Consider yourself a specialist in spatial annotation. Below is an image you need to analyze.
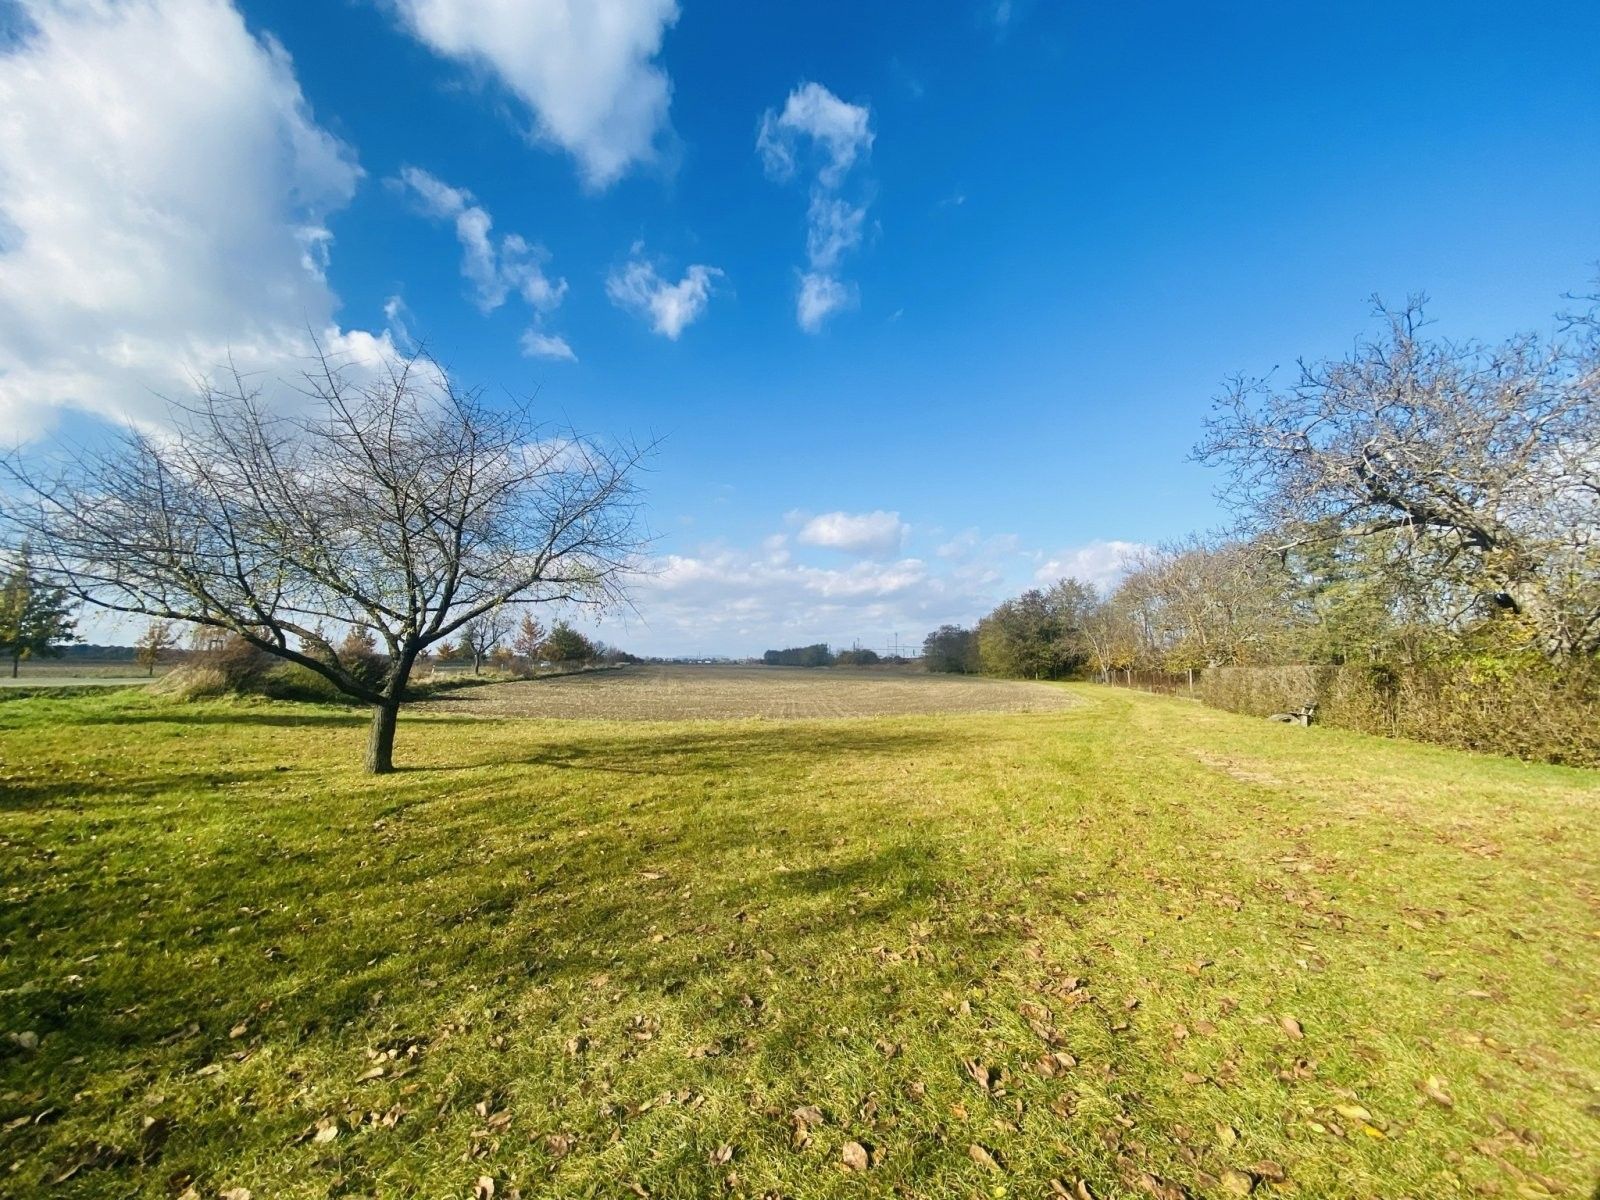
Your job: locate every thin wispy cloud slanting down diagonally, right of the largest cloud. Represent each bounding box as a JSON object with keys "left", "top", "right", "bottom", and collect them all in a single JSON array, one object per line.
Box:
[{"left": 398, "top": 166, "right": 578, "bottom": 362}]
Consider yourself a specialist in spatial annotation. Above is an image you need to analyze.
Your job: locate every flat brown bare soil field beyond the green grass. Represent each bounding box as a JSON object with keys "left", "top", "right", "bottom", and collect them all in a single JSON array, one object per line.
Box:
[{"left": 414, "top": 664, "right": 1078, "bottom": 722}]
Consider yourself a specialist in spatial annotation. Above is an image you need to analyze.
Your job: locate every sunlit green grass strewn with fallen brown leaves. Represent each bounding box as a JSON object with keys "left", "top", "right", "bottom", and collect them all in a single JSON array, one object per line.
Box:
[{"left": 0, "top": 688, "right": 1600, "bottom": 1200}]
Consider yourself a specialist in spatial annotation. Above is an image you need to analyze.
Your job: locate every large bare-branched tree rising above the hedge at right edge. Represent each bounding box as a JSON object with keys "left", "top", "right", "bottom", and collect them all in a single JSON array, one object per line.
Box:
[{"left": 1195, "top": 301, "right": 1600, "bottom": 656}]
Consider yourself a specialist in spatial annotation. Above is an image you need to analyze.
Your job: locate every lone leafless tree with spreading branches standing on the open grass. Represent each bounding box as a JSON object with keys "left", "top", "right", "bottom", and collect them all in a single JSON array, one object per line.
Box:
[{"left": 0, "top": 358, "right": 642, "bottom": 773}]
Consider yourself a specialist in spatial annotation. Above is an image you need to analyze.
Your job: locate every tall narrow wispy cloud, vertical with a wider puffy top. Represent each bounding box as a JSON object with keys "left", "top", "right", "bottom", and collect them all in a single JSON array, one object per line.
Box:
[{"left": 755, "top": 82, "right": 875, "bottom": 333}]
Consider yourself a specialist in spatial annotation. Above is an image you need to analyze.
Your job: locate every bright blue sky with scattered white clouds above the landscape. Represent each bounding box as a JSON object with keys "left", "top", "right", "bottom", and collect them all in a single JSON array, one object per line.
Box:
[{"left": 0, "top": 0, "right": 1600, "bottom": 653}]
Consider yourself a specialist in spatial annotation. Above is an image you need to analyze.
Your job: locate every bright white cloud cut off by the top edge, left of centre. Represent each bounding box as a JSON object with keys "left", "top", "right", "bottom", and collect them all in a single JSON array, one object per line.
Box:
[{"left": 390, "top": 0, "right": 678, "bottom": 187}]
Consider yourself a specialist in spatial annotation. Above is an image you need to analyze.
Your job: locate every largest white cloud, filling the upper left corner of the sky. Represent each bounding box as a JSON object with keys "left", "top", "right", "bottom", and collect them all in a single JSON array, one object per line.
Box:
[{"left": 0, "top": 0, "right": 406, "bottom": 435}]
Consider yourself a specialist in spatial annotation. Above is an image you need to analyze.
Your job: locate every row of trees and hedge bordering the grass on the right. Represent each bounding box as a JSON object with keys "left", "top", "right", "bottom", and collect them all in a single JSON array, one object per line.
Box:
[{"left": 923, "top": 298, "right": 1600, "bottom": 763}]
